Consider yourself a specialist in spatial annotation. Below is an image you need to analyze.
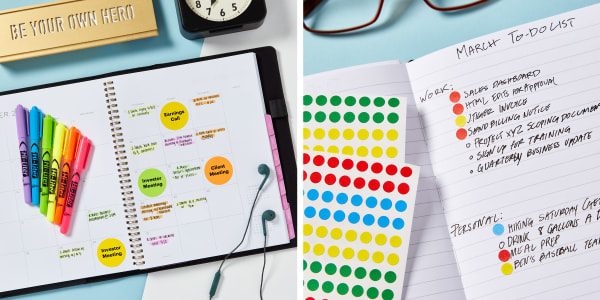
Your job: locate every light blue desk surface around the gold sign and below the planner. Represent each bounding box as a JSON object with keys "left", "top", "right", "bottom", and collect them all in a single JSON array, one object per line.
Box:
[{"left": 0, "top": 0, "right": 202, "bottom": 300}]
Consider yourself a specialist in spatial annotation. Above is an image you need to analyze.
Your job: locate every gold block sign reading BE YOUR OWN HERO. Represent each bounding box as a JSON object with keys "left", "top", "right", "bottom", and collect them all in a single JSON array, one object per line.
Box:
[{"left": 0, "top": 0, "right": 158, "bottom": 63}]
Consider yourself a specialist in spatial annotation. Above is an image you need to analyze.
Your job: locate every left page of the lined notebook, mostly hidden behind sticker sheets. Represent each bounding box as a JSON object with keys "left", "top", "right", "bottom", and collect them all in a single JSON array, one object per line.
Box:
[{"left": 304, "top": 62, "right": 464, "bottom": 299}]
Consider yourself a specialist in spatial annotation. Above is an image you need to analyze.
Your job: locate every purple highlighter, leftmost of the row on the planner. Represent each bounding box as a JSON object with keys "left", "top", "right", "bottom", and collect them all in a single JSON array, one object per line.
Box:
[{"left": 15, "top": 104, "right": 31, "bottom": 204}]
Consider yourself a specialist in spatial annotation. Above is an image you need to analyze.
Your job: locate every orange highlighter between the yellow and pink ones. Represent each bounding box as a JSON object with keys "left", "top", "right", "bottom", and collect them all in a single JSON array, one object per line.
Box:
[{"left": 54, "top": 127, "right": 80, "bottom": 225}]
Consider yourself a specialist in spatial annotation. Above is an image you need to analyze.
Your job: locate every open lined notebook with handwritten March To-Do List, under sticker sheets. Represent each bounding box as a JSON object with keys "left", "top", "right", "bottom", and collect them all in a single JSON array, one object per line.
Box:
[{"left": 304, "top": 5, "right": 600, "bottom": 299}]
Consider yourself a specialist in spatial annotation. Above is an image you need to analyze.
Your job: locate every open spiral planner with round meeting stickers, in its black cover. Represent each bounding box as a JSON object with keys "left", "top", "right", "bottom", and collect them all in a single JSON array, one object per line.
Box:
[{"left": 0, "top": 48, "right": 296, "bottom": 296}]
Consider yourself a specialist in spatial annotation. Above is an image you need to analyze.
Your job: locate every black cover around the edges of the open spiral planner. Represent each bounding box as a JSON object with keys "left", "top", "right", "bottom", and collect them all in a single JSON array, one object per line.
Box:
[{"left": 0, "top": 47, "right": 298, "bottom": 298}]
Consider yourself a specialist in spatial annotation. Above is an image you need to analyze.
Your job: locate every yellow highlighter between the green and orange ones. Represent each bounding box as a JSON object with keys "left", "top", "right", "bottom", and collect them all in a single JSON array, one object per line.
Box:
[{"left": 46, "top": 123, "right": 67, "bottom": 222}]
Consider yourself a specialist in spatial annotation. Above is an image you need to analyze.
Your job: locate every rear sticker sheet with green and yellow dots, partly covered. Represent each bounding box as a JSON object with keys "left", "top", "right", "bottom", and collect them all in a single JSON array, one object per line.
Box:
[{"left": 302, "top": 95, "right": 406, "bottom": 161}]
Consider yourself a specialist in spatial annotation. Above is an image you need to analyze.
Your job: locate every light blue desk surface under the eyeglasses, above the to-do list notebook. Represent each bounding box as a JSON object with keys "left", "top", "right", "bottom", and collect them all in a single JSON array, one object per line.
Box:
[{"left": 304, "top": 0, "right": 600, "bottom": 75}]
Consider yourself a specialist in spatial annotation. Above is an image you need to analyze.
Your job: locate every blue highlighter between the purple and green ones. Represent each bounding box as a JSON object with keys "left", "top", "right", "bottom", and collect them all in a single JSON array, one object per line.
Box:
[{"left": 29, "top": 106, "right": 44, "bottom": 206}]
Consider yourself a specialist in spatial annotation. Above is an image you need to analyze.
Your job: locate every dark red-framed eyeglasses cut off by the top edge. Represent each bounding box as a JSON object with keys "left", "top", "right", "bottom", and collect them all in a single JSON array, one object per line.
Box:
[{"left": 304, "top": 0, "right": 488, "bottom": 34}]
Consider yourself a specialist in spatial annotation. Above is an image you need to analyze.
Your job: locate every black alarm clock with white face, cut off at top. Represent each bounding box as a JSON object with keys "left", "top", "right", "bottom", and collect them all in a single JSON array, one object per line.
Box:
[{"left": 176, "top": 0, "right": 266, "bottom": 40}]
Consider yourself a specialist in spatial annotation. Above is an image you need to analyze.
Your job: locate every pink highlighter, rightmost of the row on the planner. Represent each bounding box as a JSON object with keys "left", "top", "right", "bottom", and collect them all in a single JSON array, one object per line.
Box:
[{"left": 60, "top": 136, "right": 92, "bottom": 234}]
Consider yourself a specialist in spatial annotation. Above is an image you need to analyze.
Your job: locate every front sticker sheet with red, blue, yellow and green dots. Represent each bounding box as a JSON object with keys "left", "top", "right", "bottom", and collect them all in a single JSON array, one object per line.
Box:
[{"left": 302, "top": 151, "right": 419, "bottom": 300}]
